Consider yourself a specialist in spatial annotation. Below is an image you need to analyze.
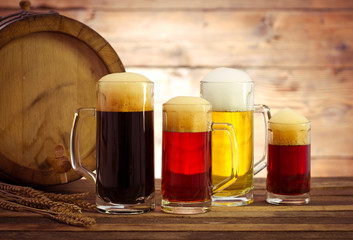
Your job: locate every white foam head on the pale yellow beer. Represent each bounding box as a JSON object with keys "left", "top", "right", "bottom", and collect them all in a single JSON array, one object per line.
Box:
[{"left": 201, "top": 67, "right": 254, "bottom": 112}]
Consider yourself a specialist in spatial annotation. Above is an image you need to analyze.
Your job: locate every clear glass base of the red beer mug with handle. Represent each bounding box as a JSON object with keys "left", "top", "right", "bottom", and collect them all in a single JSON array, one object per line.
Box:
[{"left": 161, "top": 199, "right": 211, "bottom": 214}]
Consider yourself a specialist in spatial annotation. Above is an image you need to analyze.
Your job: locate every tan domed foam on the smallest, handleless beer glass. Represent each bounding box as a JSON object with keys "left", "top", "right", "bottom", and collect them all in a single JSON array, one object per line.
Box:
[{"left": 270, "top": 108, "right": 310, "bottom": 146}]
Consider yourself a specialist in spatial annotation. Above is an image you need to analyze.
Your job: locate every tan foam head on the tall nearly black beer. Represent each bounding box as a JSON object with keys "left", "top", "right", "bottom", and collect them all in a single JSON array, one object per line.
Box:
[{"left": 97, "top": 72, "right": 153, "bottom": 112}]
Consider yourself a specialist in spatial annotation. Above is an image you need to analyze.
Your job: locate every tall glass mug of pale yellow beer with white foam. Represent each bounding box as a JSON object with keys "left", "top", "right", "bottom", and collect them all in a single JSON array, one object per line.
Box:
[{"left": 201, "top": 68, "right": 270, "bottom": 206}]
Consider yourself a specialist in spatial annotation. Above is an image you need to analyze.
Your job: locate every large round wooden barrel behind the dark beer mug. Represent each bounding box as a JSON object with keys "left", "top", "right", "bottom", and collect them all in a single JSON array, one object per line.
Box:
[{"left": 0, "top": 1, "right": 125, "bottom": 186}]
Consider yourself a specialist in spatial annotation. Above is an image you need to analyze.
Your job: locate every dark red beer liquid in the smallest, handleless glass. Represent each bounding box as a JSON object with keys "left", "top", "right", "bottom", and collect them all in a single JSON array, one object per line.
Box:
[{"left": 267, "top": 144, "right": 310, "bottom": 195}]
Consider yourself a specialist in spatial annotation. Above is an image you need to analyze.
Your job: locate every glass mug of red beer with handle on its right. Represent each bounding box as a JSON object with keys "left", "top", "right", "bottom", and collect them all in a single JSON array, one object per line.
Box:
[{"left": 161, "top": 97, "right": 237, "bottom": 214}]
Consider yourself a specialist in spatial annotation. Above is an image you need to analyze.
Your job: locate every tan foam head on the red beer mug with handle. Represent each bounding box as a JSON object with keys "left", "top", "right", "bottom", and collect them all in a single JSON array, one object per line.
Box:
[{"left": 163, "top": 96, "right": 212, "bottom": 132}]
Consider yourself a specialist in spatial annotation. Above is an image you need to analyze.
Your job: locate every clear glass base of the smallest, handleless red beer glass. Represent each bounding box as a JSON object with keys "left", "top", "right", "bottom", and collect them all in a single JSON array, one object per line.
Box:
[{"left": 266, "top": 192, "right": 310, "bottom": 205}]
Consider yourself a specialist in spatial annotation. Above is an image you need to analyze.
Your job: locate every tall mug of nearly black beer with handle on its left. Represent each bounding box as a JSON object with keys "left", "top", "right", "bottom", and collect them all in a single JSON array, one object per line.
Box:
[{"left": 70, "top": 73, "right": 155, "bottom": 214}]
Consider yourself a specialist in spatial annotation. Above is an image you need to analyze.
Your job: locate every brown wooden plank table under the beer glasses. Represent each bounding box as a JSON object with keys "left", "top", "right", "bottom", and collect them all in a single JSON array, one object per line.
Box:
[{"left": 0, "top": 177, "right": 353, "bottom": 240}]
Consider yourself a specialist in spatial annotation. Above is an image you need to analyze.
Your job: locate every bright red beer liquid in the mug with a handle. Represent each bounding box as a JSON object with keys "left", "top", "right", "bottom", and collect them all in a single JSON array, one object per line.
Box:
[{"left": 162, "top": 131, "right": 211, "bottom": 202}]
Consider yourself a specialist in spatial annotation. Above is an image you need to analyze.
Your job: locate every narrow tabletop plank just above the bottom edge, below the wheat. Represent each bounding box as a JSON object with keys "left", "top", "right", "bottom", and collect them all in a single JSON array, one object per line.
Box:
[{"left": 0, "top": 223, "right": 353, "bottom": 232}]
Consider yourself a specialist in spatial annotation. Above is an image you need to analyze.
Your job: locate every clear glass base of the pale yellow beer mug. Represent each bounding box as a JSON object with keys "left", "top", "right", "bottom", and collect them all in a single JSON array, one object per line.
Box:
[{"left": 212, "top": 191, "right": 254, "bottom": 207}]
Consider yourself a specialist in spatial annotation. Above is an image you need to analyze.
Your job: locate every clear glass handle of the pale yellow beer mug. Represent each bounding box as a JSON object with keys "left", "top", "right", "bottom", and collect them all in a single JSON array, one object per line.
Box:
[{"left": 254, "top": 104, "right": 271, "bottom": 175}]
